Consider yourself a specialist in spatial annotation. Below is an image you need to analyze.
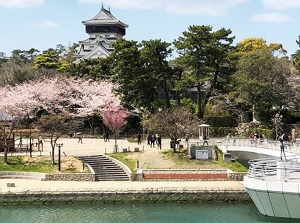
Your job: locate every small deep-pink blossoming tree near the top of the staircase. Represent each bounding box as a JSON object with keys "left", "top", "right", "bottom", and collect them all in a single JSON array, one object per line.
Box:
[{"left": 103, "top": 104, "right": 128, "bottom": 152}]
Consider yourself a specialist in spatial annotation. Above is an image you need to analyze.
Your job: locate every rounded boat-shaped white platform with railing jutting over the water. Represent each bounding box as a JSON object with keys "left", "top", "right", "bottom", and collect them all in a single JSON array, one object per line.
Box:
[{"left": 244, "top": 155, "right": 300, "bottom": 219}]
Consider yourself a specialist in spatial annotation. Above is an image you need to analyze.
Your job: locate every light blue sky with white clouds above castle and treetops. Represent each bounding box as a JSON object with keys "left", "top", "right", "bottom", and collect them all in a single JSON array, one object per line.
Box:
[{"left": 0, "top": 0, "right": 300, "bottom": 56}]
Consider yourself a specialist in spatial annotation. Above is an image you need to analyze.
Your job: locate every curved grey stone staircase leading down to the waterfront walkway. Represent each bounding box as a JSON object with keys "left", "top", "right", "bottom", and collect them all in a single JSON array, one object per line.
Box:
[{"left": 78, "top": 155, "right": 130, "bottom": 181}]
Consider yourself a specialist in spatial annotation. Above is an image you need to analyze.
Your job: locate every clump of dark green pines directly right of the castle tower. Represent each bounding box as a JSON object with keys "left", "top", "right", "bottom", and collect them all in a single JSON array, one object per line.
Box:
[{"left": 110, "top": 39, "right": 175, "bottom": 111}]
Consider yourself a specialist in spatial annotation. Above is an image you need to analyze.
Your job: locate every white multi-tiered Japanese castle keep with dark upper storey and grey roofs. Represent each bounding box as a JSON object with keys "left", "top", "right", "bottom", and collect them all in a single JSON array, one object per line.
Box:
[{"left": 74, "top": 5, "right": 128, "bottom": 63}]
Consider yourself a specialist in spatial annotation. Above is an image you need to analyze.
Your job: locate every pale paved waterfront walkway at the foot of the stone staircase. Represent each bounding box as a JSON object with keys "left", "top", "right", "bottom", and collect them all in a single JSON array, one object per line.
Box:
[{"left": 0, "top": 179, "right": 245, "bottom": 193}]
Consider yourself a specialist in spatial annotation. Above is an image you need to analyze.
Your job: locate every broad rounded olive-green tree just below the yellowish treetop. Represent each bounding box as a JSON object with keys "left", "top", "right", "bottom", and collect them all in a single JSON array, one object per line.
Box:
[{"left": 233, "top": 49, "right": 299, "bottom": 124}]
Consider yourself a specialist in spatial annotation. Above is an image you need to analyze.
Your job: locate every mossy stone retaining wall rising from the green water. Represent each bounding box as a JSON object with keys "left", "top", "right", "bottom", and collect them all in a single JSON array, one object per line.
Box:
[{"left": 0, "top": 188, "right": 252, "bottom": 206}]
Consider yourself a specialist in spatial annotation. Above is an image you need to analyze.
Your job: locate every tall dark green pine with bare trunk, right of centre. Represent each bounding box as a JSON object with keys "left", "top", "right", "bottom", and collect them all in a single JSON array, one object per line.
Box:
[{"left": 174, "top": 26, "right": 235, "bottom": 118}]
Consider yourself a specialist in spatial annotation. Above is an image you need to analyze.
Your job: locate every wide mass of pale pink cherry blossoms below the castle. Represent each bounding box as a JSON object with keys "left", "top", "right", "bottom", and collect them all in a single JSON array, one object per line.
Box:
[{"left": 0, "top": 77, "right": 120, "bottom": 163}]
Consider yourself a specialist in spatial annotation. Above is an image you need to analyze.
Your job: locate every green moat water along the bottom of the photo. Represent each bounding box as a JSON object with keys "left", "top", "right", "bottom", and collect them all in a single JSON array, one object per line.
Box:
[{"left": 0, "top": 204, "right": 299, "bottom": 223}]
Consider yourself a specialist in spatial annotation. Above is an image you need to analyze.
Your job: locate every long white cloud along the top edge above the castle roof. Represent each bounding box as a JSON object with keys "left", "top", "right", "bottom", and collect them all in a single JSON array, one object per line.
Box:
[{"left": 78, "top": 0, "right": 250, "bottom": 16}]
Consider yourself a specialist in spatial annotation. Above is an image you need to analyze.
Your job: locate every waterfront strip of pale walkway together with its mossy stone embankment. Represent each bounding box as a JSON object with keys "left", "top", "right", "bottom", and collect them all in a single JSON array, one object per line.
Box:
[{"left": 0, "top": 179, "right": 252, "bottom": 206}]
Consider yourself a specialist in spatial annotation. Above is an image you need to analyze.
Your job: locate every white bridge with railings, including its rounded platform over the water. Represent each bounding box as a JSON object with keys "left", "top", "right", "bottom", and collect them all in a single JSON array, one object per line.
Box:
[{"left": 217, "top": 139, "right": 300, "bottom": 218}]
